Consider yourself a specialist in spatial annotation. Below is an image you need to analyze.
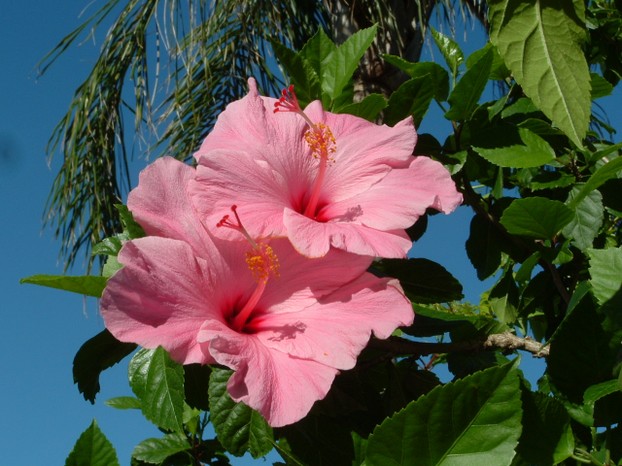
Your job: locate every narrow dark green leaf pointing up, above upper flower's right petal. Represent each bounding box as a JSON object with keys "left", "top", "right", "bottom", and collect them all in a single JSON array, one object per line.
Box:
[{"left": 445, "top": 49, "right": 493, "bottom": 121}]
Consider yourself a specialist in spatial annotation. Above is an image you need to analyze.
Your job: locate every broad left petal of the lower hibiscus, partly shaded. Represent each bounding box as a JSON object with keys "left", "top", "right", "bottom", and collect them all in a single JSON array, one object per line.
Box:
[{"left": 100, "top": 237, "right": 222, "bottom": 364}]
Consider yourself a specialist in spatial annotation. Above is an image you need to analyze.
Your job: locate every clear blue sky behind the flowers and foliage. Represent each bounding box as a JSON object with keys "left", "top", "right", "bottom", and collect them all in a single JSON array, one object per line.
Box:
[{"left": 0, "top": 0, "right": 620, "bottom": 466}]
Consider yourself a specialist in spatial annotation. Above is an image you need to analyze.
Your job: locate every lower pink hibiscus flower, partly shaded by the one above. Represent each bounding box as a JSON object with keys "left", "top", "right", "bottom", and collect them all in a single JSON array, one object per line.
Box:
[{"left": 101, "top": 158, "right": 413, "bottom": 426}]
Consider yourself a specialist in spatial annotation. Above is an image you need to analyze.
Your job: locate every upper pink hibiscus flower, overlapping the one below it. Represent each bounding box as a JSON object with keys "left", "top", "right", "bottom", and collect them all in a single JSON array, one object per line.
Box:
[{"left": 191, "top": 79, "right": 462, "bottom": 257}]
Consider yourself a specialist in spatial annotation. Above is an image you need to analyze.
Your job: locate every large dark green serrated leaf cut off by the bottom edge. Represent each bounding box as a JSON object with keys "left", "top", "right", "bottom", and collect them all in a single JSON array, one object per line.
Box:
[{"left": 365, "top": 363, "right": 522, "bottom": 466}]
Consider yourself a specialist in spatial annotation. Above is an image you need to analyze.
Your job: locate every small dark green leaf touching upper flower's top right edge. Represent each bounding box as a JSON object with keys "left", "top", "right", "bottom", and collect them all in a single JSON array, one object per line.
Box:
[{"left": 384, "top": 76, "right": 434, "bottom": 126}]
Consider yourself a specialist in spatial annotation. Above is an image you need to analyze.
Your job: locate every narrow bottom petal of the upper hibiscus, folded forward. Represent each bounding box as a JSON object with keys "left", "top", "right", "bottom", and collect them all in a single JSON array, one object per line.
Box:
[{"left": 283, "top": 209, "right": 412, "bottom": 258}]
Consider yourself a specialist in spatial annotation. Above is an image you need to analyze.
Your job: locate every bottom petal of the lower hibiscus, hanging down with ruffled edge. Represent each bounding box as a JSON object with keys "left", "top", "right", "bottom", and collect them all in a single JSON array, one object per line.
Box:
[{"left": 199, "top": 321, "right": 338, "bottom": 427}]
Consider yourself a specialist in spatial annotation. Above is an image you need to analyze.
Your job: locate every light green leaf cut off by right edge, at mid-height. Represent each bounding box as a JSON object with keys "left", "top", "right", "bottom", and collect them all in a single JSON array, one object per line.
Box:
[{"left": 587, "top": 247, "right": 622, "bottom": 306}]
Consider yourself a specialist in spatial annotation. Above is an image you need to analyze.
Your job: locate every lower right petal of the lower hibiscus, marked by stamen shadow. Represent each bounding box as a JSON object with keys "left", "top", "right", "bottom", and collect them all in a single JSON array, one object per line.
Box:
[{"left": 253, "top": 273, "right": 414, "bottom": 369}]
